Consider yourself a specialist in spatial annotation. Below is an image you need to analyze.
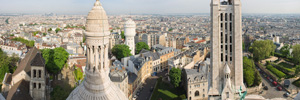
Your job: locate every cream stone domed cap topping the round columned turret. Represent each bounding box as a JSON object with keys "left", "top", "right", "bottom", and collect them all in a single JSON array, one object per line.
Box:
[{"left": 85, "top": 0, "right": 110, "bottom": 37}]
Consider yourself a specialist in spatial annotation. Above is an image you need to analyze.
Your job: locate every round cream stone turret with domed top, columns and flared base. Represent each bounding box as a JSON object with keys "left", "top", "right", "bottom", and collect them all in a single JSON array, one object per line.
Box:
[{"left": 67, "top": 0, "right": 128, "bottom": 100}]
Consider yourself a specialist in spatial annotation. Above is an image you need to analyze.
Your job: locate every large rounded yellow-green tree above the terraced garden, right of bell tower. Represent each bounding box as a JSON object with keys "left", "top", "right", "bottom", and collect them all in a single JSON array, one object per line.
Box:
[{"left": 251, "top": 40, "right": 276, "bottom": 61}]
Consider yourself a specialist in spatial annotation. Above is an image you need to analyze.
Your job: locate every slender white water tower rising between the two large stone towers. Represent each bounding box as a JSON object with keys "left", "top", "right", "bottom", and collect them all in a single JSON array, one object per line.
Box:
[{"left": 124, "top": 19, "right": 136, "bottom": 55}]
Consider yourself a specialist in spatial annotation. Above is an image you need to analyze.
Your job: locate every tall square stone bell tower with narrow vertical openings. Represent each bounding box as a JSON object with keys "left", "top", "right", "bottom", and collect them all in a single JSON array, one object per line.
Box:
[{"left": 208, "top": 0, "right": 246, "bottom": 100}]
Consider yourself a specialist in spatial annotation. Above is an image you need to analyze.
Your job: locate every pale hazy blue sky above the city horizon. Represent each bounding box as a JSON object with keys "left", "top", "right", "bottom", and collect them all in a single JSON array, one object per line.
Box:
[{"left": 0, "top": 0, "right": 300, "bottom": 14}]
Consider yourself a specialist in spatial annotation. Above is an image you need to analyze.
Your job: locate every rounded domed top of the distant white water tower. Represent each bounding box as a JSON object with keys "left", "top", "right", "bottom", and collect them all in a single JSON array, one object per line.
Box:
[{"left": 124, "top": 19, "right": 136, "bottom": 37}]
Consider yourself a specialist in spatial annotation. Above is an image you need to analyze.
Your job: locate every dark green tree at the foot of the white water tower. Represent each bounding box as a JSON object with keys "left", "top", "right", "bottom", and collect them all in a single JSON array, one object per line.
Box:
[{"left": 111, "top": 45, "right": 132, "bottom": 60}]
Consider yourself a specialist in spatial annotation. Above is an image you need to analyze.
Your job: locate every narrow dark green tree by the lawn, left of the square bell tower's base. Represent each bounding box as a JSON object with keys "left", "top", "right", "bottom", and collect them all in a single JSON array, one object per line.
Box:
[{"left": 169, "top": 68, "right": 181, "bottom": 88}]
